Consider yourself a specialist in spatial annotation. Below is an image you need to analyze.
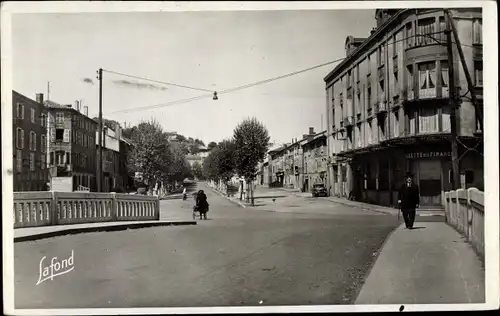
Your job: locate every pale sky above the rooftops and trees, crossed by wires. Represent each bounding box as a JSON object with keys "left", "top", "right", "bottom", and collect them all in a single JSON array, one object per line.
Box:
[{"left": 12, "top": 9, "right": 375, "bottom": 144}]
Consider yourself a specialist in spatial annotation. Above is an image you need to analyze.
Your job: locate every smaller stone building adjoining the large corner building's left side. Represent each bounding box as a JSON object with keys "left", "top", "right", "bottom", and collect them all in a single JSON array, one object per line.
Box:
[{"left": 302, "top": 131, "right": 328, "bottom": 192}]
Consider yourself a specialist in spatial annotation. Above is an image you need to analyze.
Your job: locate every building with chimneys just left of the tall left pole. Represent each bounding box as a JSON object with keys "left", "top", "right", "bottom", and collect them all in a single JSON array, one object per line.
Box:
[{"left": 45, "top": 100, "right": 97, "bottom": 191}]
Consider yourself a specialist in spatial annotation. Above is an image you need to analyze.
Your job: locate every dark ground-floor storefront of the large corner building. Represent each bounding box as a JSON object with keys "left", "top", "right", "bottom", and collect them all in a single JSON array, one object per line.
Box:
[{"left": 344, "top": 140, "right": 484, "bottom": 208}]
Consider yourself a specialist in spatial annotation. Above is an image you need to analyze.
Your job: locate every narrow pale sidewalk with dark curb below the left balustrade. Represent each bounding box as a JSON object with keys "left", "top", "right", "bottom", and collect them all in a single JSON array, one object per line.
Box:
[{"left": 14, "top": 220, "right": 196, "bottom": 242}]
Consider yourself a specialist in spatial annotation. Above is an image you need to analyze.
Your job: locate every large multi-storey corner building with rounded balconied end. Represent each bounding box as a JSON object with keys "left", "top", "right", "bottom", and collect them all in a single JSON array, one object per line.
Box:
[{"left": 324, "top": 8, "right": 483, "bottom": 206}]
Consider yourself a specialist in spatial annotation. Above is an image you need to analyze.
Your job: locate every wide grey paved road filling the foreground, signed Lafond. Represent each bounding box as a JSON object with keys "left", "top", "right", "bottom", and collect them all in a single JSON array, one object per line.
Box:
[{"left": 14, "top": 183, "right": 398, "bottom": 308}]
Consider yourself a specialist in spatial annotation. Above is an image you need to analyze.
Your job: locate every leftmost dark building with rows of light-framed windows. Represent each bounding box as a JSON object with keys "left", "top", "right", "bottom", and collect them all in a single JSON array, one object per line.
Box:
[{"left": 12, "top": 91, "right": 48, "bottom": 191}]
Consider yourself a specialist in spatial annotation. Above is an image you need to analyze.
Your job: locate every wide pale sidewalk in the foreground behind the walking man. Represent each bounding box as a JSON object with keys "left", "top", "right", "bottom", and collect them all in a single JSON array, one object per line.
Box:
[{"left": 356, "top": 222, "right": 485, "bottom": 305}]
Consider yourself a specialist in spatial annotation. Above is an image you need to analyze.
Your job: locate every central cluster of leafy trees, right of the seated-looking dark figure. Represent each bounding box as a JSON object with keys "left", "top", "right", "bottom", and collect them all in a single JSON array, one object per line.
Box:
[{"left": 202, "top": 118, "right": 270, "bottom": 204}]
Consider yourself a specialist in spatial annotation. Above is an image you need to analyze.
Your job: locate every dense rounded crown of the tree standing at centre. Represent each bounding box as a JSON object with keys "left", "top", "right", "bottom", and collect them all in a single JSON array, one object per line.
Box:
[{"left": 233, "top": 118, "right": 270, "bottom": 180}]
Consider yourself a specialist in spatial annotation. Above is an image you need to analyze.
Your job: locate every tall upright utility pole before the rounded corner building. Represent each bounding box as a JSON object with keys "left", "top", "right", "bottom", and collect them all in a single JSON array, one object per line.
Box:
[{"left": 445, "top": 10, "right": 460, "bottom": 190}]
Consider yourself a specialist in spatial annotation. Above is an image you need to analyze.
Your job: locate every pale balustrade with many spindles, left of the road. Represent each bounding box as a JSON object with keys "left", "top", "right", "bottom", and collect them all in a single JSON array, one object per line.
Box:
[{"left": 14, "top": 192, "right": 160, "bottom": 228}]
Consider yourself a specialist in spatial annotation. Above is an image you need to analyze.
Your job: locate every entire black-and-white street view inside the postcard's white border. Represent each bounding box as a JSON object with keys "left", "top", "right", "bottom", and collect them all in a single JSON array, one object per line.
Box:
[{"left": 2, "top": 2, "right": 488, "bottom": 313}]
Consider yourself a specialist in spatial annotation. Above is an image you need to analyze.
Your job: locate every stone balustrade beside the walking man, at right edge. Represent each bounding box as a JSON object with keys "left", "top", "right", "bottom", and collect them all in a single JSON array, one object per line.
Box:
[{"left": 445, "top": 188, "right": 484, "bottom": 258}]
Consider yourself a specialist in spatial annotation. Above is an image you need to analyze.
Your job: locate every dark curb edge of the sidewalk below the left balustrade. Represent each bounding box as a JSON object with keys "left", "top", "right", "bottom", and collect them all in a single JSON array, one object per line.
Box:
[{"left": 14, "top": 221, "right": 196, "bottom": 242}]
